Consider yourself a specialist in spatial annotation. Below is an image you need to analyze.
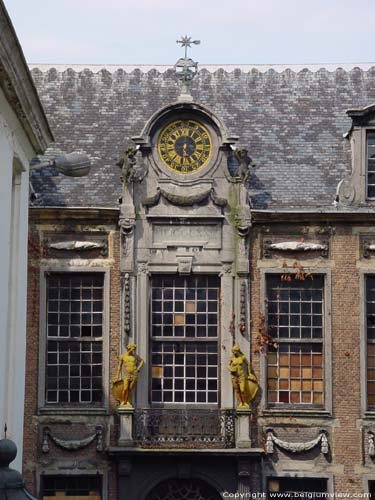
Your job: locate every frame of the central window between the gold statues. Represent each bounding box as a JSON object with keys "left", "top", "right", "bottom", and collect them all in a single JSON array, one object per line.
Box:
[{"left": 147, "top": 271, "right": 222, "bottom": 410}]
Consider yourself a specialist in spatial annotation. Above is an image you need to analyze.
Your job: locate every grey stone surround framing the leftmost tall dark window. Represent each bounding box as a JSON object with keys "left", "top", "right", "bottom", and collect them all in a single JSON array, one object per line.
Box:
[{"left": 38, "top": 265, "right": 110, "bottom": 414}]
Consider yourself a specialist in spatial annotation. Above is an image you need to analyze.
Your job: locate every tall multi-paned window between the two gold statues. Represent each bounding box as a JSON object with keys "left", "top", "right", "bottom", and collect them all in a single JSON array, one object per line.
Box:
[{"left": 151, "top": 276, "right": 220, "bottom": 404}]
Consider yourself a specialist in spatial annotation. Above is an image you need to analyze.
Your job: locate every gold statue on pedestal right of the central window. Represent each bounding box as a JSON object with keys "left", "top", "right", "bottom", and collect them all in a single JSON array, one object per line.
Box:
[{"left": 227, "top": 345, "right": 259, "bottom": 410}]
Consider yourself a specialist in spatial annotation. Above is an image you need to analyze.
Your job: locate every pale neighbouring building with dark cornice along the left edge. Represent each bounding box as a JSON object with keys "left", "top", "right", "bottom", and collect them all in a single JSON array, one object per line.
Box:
[{"left": 0, "top": 2, "right": 53, "bottom": 469}]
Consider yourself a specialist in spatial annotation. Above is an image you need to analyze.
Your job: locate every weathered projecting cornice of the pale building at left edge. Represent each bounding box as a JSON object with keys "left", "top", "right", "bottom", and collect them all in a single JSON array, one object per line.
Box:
[{"left": 0, "top": 0, "right": 54, "bottom": 153}]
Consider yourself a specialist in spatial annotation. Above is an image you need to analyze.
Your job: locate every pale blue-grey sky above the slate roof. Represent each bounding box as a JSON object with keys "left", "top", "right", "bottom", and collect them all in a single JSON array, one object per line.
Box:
[{"left": 5, "top": 0, "right": 375, "bottom": 65}]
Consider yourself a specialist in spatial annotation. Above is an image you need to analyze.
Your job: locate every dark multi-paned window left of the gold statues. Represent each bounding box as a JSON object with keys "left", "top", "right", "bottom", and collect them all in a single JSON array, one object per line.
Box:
[{"left": 46, "top": 273, "right": 104, "bottom": 404}]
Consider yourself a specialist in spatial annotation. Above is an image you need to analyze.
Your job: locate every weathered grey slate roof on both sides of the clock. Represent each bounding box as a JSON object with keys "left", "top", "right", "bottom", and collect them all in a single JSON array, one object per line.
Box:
[{"left": 31, "top": 63, "right": 375, "bottom": 209}]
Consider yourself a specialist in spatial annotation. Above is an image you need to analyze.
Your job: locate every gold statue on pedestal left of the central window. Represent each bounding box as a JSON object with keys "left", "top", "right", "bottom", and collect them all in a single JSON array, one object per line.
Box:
[{"left": 112, "top": 344, "right": 144, "bottom": 408}]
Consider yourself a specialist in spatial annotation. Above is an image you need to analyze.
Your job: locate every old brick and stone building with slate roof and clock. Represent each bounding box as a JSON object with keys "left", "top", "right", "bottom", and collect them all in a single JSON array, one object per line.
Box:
[{"left": 24, "top": 56, "right": 375, "bottom": 500}]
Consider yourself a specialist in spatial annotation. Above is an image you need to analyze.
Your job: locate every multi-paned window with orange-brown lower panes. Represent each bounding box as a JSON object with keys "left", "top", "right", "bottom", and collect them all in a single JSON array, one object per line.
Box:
[{"left": 267, "top": 275, "right": 324, "bottom": 406}]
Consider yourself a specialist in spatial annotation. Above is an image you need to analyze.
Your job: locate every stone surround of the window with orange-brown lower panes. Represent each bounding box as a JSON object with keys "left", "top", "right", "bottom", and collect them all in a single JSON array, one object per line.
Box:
[{"left": 260, "top": 266, "right": 332, "bottom": 417}]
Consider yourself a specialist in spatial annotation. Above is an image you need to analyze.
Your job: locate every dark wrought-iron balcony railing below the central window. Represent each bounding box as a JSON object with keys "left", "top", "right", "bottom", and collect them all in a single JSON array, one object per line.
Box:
[{"left": 133, "top": 408, "right": 235, "bottom": 448}]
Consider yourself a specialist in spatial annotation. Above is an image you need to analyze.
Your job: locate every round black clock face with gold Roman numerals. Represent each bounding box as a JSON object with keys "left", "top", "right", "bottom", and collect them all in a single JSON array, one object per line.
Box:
[{"left": 158, "top": 120, "right": 212, "bottom": 174}]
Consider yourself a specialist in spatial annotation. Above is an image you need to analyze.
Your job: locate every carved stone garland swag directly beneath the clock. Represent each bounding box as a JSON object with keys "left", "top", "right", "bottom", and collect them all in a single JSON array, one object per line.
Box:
[{"left": 142, "top": 186, "right": 228, "bottom": 207}]
